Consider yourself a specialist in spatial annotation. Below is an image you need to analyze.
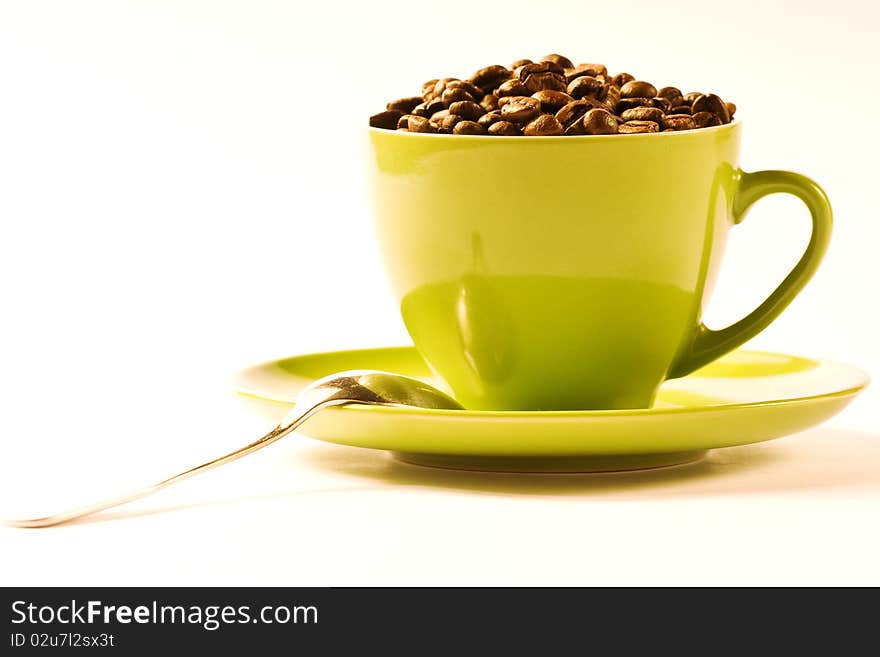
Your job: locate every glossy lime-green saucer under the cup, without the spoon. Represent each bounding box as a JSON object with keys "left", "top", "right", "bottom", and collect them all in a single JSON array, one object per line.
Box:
[{"left": 238, "top": 347, "right": 868, "bottom": 472}]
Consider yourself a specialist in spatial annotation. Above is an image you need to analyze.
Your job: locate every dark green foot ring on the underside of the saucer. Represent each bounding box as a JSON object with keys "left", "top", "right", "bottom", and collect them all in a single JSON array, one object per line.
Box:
[{"left": 392, "top": 450, "right": 707, "bottom": 474}]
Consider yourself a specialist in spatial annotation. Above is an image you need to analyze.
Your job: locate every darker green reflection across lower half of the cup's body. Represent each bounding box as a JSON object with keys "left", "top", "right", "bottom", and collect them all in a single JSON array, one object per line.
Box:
[{"left": 401, "top": 274, "right": 694, "bottom": 410}]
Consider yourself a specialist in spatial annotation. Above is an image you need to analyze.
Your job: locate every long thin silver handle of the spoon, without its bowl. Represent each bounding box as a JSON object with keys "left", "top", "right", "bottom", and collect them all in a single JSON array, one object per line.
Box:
[{"left": 9, "top": 397, "right": 351, "bottom": 528}]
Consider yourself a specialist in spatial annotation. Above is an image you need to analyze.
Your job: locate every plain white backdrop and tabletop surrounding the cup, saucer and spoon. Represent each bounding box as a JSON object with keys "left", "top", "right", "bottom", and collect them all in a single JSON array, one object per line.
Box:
[{"left": 0, "top": 0, "right": 880, "bottom": 584}]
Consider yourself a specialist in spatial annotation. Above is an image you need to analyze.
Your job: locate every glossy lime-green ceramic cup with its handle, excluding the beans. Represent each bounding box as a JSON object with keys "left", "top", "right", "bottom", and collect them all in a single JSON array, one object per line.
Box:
[{"left": 370, "top": 123, "right": 831, "bottom": 410}]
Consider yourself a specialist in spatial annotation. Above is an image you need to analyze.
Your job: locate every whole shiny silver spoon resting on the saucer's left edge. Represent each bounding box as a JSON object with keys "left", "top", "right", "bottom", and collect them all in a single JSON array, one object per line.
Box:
[{"left": 5, "top": 370, "right": 462, "bottom": 527}]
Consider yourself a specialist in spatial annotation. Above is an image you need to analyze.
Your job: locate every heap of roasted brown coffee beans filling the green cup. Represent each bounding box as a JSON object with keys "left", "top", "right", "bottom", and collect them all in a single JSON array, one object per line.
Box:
[{"left": 370, "top": 54, "right": 736, "bottom": 137}]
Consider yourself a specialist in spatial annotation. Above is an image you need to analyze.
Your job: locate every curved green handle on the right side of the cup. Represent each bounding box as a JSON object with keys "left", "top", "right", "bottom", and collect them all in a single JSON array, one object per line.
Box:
[{"left": 667, "top": 171, "right": 832, "bottom": 379}]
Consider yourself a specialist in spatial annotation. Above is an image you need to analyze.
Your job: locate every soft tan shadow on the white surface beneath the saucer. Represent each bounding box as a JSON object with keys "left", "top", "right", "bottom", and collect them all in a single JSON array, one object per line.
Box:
[{"left": 291, "top": 428, "right": 880, "bottom": 498}]
